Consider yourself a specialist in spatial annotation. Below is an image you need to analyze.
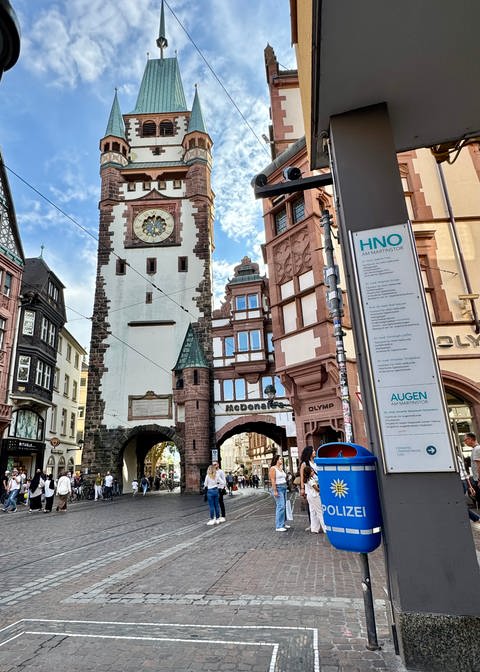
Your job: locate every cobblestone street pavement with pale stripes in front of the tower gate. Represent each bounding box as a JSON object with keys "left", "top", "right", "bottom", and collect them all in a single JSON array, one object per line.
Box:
[{"left": 0, "top": 490, "right": 480, "bottom": 672}]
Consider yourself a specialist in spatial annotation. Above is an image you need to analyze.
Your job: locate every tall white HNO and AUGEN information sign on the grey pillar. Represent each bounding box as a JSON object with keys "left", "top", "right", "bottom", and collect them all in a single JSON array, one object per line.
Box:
[{"left": 351, "top": 224, "right": 455, "bottom": 473}]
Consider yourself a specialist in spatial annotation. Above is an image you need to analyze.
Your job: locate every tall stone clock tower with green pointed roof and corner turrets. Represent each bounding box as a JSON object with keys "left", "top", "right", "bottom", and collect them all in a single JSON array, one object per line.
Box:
[{"left": 83, "top": 3, "right": 213, "bottom": 491}]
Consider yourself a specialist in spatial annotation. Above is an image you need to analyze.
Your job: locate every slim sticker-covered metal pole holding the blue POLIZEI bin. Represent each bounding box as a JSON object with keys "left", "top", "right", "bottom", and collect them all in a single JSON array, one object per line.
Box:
[{"left": 322, "top": 210, "right": 381, "bottom": 651}]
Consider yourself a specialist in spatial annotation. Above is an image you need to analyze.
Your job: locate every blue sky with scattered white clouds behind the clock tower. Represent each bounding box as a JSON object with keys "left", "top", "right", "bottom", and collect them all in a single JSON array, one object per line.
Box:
[{"left": 0, "top": 0, "right": 295, "bottom": 349}]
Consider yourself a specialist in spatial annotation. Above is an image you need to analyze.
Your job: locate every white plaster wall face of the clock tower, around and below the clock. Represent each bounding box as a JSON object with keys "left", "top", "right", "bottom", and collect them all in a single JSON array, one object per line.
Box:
[{"left": 102, "top": 197, "right": 203, "bottom": 428}]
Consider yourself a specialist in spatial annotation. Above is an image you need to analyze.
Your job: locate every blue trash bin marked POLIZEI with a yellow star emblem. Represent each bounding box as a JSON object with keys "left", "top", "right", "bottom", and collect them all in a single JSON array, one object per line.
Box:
[{"left": 315, "top": 443, "right": 382, "bottom": 553}]
